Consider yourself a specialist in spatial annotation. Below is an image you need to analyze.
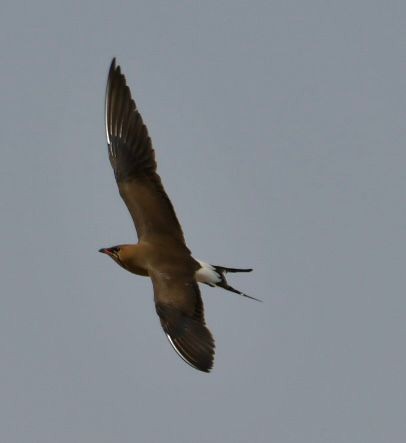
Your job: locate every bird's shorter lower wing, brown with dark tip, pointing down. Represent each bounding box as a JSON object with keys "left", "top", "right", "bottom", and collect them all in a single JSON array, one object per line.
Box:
[{"left": 150, "top": 272, "right": 215, "bottom": 372}]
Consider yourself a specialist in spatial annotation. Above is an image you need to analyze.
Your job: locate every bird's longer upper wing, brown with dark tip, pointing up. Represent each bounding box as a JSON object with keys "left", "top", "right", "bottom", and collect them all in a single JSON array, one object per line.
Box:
[{"left": 105, "top": 59, "right": 184, "bottom": 243}]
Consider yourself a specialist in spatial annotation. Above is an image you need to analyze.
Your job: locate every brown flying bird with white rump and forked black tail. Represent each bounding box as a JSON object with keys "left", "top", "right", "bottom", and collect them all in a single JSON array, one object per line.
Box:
[{"left": 99, "top": 58, "right": 261, "bottom": 372}]
